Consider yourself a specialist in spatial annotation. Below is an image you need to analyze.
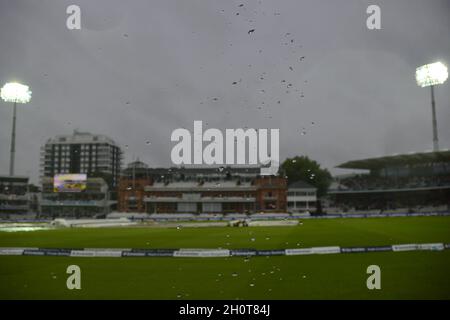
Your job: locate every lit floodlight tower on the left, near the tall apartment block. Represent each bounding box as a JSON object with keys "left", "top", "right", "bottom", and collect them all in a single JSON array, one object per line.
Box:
[{"left": 0, "top": 82, "right": 31, "bottom": 176}]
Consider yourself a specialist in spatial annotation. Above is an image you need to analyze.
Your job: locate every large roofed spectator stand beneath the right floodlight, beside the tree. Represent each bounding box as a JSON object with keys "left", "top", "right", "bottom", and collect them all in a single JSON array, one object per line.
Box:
[{"left": 327, "top": 150, "right": 450, "bottom": 213}]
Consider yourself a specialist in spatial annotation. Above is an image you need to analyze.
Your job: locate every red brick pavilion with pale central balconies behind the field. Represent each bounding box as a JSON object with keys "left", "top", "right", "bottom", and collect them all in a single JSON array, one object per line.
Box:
[{"left": 119, "top": 167, "right": 287, "bottom": 213}]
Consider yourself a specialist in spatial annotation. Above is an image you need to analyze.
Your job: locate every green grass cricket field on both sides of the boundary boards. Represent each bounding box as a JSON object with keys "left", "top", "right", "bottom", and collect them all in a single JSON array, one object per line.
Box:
[{"left": 0, "top": 217, "right": 450, "bottom": 299}]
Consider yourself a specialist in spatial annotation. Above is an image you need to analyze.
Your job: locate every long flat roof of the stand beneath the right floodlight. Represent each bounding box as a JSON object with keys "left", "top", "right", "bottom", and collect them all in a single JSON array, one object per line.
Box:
[{"left": 336, "top": 149, "right": 450, "bottom": 170}]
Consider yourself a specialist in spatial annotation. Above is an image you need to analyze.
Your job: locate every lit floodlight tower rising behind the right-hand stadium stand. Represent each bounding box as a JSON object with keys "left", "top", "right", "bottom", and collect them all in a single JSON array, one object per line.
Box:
[{"left": 416, "top": 62, "right": 448, "bottom": 151}]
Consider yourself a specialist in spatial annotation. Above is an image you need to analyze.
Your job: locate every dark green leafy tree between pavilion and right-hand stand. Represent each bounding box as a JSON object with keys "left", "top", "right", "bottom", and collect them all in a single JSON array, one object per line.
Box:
[{"left": 279, "top": 156, "right": 332, "bottom": 197}]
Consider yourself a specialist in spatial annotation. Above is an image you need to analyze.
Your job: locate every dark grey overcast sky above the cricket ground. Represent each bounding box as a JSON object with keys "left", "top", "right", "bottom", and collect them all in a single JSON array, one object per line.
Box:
[{"left": 0, "top": 0, "right": 450, "bottom": 182}]
